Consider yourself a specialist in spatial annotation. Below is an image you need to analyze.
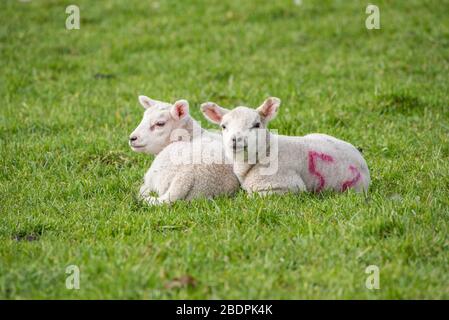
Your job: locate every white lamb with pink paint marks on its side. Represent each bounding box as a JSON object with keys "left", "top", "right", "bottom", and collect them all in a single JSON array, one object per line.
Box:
[{"left": 201, "top": 97, "right": 370, "bottom": 195}]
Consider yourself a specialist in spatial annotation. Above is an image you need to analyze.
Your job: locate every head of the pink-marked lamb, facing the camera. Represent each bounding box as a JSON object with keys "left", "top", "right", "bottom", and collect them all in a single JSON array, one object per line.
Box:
[{"left": 201, "top": 97, "right": 281, "bottom": 155}]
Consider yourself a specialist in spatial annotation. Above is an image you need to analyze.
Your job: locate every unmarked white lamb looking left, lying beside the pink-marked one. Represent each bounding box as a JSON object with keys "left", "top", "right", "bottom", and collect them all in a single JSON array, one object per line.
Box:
[{"left": 129, "top": 96, "right": 240, "bottom": 205}]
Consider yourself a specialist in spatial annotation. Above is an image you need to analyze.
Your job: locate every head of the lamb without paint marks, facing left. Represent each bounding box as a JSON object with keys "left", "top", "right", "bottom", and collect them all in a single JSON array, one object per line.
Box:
[{"left": 129, "top": 96, "right": 190, "bottom": 154}]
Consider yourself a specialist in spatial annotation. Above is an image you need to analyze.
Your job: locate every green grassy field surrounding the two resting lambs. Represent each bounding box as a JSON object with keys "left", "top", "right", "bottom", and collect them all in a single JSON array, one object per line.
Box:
[{"left": 0, "top": 0, "right": 449, "bottom": 299}]
